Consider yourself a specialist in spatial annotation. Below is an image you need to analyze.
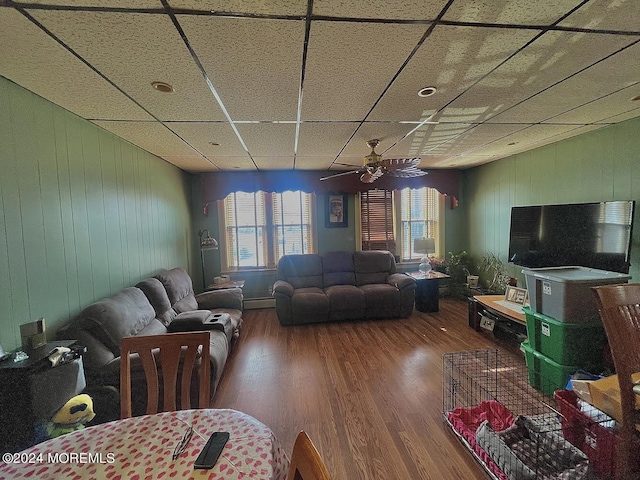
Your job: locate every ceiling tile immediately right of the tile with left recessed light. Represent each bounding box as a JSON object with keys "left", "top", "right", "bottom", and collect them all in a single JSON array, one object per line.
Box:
[{"left": 178, "top": 15, "right": 304, "bottom": 121}]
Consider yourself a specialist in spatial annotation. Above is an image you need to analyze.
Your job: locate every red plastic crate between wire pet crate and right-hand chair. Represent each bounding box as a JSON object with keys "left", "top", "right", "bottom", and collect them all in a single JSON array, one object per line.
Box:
[{"left": 554, "top": 390, "right": 640, "bottom": 478}]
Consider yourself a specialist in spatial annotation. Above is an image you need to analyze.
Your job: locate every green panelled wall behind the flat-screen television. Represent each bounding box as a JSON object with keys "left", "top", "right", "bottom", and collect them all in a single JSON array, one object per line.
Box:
[{"left": 460, "top": 118, "right": 640, "bottom": 285}]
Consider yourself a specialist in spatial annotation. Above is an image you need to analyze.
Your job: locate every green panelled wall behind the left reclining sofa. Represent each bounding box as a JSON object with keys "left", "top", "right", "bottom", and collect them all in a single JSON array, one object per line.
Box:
[{"left": 0, "top": 77, "right": 195, "bottom": 350}]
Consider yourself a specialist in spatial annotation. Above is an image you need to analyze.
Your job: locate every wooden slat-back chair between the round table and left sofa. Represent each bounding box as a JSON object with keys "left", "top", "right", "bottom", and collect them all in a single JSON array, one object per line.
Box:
[{"left": 120, "top": 331, "right": 211, "bottom": 418}]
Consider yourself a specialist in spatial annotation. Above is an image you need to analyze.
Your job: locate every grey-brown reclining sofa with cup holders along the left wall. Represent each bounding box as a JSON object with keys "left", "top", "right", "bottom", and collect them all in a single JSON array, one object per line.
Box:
[{"left": 57, "top": 268, "right": 243, "bottom": 413}]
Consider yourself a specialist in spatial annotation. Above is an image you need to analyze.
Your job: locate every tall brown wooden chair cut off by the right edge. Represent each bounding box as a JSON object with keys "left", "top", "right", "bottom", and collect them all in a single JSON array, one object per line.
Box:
[{"left": 592, "top": 283, "right": 640, "bottom": 480}]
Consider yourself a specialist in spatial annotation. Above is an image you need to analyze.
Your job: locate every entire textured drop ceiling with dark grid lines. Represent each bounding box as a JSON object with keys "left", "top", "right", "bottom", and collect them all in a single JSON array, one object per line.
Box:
[{"left": 0, "top": 0, "right": 640, "bottom": 173}]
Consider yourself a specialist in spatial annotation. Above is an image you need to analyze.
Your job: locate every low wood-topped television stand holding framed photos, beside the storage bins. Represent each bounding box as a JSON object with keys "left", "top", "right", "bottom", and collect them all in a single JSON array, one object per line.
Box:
[{"left": 469, "top": 295, "right": 527, "bottom": 346}]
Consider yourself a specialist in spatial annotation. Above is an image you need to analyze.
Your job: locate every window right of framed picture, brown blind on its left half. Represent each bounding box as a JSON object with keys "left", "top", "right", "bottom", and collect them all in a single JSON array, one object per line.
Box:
[{"left": 359, "top": 187, "right": 443, "bottom": 261}]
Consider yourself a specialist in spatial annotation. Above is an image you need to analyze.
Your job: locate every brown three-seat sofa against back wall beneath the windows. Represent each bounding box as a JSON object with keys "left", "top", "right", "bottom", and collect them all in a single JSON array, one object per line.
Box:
[{"left": 273, "top": 251, "right": 416, "bottom": 325}]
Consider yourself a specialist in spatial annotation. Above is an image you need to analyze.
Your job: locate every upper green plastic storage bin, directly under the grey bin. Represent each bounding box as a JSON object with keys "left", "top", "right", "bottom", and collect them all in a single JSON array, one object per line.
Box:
[{"left": 522, "top": 307, "right": 607, "bottom": 373}]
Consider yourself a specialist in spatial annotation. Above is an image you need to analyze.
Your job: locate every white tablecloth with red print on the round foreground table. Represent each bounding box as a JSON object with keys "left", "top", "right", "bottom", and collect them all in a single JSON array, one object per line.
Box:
[{"left": 0, "top": 409, "right": 289, "bottom": 480}]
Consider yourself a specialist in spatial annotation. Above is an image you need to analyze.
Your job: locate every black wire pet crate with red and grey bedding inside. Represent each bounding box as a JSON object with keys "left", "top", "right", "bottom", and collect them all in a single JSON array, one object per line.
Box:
[{"left": 442, "top": 350, "right": 610, "bottom": 480}]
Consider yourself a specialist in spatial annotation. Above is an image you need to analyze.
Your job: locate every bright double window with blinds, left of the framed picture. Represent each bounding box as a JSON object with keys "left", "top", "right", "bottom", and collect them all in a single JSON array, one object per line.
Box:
[{"left": 221, "top": 191, "right": 314, "bottom": 270}]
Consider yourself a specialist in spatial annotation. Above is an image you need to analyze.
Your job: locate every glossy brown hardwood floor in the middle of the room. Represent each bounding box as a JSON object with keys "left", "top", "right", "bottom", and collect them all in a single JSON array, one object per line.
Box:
[{"left": 213, "top": 299, "right": 517, "bottom": 480}]
